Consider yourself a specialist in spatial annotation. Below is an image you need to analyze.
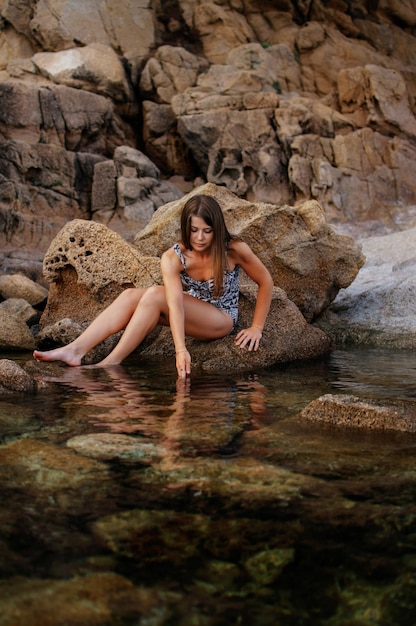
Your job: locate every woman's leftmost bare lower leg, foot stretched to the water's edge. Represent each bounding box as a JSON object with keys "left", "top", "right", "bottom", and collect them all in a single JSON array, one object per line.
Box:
[{"left": 33, "top": 288, "right": 145, "bottom": 366}]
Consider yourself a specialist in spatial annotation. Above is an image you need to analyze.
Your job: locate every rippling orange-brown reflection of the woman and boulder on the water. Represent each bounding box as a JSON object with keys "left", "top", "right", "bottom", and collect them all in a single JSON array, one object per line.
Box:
[{"left": 49, "top": 365, "right": 267, "bottom": 458}]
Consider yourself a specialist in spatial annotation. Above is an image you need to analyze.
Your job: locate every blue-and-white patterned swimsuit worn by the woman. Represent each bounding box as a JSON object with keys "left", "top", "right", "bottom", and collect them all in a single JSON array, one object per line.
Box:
[{"left": 173, "top": 243, "right": 240, "bottom": 328}]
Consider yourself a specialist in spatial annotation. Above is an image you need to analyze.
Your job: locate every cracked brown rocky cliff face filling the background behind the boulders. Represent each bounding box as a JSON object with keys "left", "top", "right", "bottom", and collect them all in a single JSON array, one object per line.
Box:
[{"left": 0, "top": 0, "right": 416, "bottom": 265}]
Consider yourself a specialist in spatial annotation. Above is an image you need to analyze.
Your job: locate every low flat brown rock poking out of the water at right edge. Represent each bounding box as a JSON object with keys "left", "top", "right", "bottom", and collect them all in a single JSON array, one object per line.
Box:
[{"left": 299, "top": 394, "right": 416, "bottom": 433}]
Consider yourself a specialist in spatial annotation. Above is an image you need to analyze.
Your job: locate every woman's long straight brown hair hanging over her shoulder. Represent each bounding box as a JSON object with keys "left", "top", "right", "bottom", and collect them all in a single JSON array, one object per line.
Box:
[{"left": 181, "top": 194, "right": 233, "bottom": 297}]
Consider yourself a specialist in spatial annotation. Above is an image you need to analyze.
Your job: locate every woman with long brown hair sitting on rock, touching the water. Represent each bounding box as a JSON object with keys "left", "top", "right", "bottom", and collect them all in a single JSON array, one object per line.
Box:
[{"left": 34, "top": 195, "right": 273, "bottom": 378}]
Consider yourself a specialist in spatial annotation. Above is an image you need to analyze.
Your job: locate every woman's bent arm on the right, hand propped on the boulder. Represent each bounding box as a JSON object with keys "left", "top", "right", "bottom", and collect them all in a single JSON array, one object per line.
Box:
[{"left": 231, "top": 240, "right": 273, "bottom": 352}]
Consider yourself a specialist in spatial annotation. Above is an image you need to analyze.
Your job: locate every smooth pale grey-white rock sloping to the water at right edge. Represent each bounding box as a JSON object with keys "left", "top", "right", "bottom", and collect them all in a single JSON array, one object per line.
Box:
[{"left": 317, "top": 228, "right": 416, "bottom": 349}]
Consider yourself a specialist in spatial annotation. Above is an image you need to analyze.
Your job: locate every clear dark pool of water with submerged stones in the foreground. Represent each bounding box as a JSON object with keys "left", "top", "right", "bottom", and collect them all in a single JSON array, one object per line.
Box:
[{"left": 0, "top": 349, "right": 416, "bottom": 626}]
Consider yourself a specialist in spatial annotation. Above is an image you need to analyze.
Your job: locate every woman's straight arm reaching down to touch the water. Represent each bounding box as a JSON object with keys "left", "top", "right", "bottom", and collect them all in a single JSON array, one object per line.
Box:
[{"left": 161, "top": 248, "right": 191, "bottom": 378}]
